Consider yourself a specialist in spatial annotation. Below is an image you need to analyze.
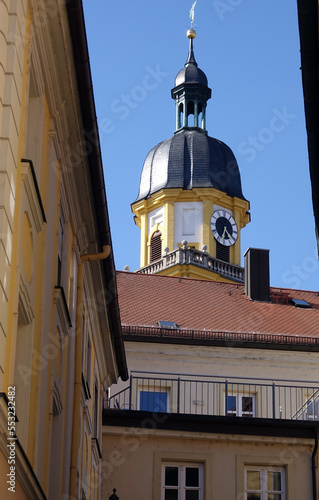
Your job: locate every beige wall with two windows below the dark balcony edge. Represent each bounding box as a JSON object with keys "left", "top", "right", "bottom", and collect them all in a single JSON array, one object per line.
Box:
[{"left": 102, "top": 426, "right": 314, "bottom": 500}]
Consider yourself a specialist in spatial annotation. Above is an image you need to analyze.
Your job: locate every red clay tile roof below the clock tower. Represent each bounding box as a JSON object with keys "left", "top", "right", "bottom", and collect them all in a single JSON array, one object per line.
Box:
[{"left": 117, "top": 271, "right": 319, "bottom": 337}]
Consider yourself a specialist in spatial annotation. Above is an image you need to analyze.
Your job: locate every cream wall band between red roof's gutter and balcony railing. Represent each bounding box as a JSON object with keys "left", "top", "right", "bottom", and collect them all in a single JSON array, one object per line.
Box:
[{"left": 120, "top": 342, "right": 319, "bottom": 391}]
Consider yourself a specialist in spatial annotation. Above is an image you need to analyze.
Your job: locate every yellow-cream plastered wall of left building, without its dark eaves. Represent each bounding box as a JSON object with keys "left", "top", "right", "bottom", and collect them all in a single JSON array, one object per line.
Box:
[{"left": 0, "top": 0, "right": 123, "bottom": 500}]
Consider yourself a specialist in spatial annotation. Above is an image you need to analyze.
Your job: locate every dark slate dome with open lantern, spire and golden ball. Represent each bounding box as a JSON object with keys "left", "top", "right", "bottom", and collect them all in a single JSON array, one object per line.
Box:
[{"left": 136, "top": 29, "right": 245, "bottom": 201}]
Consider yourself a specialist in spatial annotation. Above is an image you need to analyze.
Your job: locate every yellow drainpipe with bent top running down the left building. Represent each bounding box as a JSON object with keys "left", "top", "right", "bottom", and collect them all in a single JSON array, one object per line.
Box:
[{"left": 70, "top": 245, "right": 111, "bottom": 498}]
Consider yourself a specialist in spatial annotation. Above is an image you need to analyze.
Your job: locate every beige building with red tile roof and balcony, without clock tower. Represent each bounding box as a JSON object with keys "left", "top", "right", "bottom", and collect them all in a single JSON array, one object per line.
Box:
[{"left": 102, "top": 263, "right": 319, "bottom": 500}]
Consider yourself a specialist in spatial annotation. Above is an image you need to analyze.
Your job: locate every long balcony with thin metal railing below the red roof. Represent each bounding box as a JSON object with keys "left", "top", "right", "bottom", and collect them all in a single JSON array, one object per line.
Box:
[{"left": 104, "top": 371, "right": 319, "bottom": 421}]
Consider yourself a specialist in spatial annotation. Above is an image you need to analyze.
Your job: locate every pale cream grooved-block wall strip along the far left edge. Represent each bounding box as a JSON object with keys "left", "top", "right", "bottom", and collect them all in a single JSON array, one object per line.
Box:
[{"left": 0, "top": 0, "right": 26, "bottom": 387}]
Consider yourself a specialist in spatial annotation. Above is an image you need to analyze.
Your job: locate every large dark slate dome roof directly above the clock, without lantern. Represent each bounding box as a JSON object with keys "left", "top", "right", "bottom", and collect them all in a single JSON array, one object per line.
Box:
[{"left": 136, "top": 128, "right": 245, "bottom": 201}]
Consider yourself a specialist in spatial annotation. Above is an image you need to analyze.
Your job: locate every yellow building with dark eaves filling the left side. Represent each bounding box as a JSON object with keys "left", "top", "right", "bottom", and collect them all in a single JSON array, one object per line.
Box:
[{"left": 0, "top": 0, "right": 127, "bottom": 500}]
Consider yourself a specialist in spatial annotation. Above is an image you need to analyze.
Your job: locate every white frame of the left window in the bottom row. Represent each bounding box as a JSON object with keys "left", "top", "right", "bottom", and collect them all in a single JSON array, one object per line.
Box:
[{"left": 161, "top": 461, "right": 204, "bottom": 500}]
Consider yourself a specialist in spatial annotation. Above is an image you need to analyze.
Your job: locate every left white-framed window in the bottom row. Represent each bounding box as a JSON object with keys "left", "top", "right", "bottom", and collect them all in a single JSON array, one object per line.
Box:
[{"left": 161, "top": 463, "right": 203, "bottom": 500}]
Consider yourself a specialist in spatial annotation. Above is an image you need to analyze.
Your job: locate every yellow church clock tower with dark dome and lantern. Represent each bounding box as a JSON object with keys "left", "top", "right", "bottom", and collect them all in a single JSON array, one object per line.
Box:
[{"left": 132, "top": 29, "right": 250, "bottom": 282}]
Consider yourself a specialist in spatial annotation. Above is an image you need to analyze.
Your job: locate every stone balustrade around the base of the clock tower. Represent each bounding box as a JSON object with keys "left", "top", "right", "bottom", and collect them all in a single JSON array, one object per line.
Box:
[{"left": 136, "top": 242, "right": 245, "bottom": 283}]
